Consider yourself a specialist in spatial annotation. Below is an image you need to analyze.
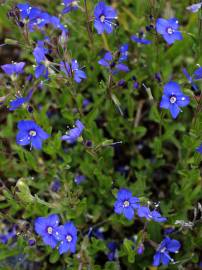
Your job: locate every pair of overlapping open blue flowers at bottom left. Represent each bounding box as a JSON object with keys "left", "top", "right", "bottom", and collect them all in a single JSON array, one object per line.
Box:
[{"left": 35, "top": 214, "right": 77, "bottom": 254}]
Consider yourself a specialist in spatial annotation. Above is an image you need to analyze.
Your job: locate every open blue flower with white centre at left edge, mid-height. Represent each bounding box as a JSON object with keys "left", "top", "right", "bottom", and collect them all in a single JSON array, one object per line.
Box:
[{"left": 16, "top": 120, "right": 50, "bottom": 149}]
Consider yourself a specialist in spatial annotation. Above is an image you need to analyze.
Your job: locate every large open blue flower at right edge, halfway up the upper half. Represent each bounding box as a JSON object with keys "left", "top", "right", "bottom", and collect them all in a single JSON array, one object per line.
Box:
[{"left": 160, "top": 81, "right": 190, "bottom": 119}]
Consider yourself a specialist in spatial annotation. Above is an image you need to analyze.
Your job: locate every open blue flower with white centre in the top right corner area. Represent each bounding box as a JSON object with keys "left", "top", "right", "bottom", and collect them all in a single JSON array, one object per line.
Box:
[{"left": 156, "top": 18, "right": 183, "bottom": 44}]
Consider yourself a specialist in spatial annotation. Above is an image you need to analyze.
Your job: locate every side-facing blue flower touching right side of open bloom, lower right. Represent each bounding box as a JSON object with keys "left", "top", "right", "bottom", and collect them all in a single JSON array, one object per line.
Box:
[{"left": 137, "top": 206, "right": 167, "bottom": 222}]
